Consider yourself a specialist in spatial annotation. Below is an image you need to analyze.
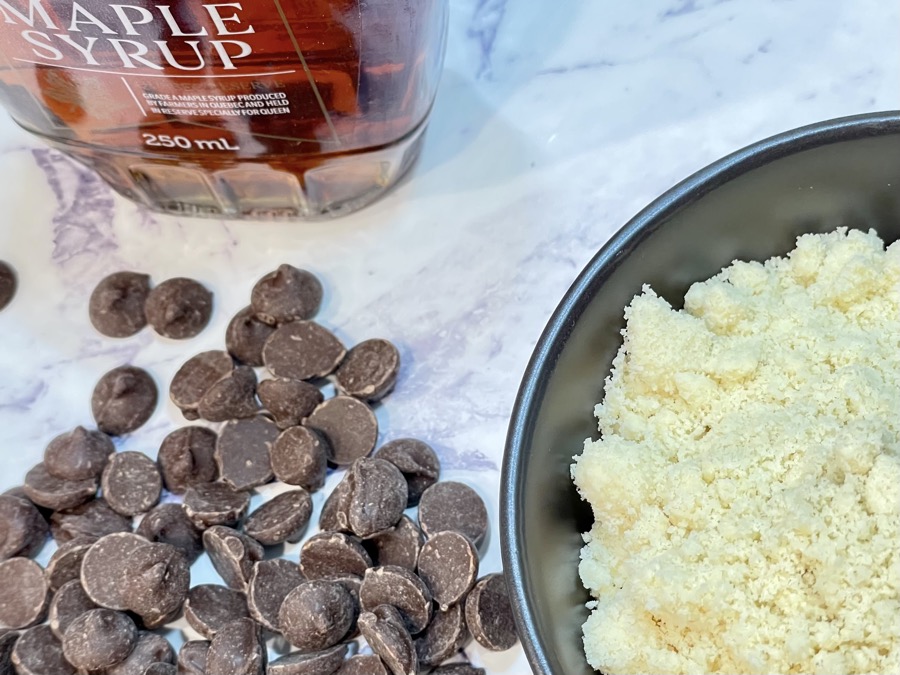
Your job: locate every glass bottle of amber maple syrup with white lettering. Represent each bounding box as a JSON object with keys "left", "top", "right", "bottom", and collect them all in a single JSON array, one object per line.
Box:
[{"left": 0, "top": 0, "right": 447, "bottom": 219}]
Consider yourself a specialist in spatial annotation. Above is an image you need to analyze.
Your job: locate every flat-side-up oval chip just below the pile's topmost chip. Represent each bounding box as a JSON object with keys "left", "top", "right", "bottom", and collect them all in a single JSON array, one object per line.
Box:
[{"left": 263, "top": 321, "right": 347, "bottom": 380}]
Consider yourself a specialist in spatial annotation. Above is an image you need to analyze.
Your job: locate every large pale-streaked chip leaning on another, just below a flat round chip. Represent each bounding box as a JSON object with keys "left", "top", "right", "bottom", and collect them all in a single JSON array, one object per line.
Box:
[{"left": 347, "top": 457, "right": 406, "bottom": 539}]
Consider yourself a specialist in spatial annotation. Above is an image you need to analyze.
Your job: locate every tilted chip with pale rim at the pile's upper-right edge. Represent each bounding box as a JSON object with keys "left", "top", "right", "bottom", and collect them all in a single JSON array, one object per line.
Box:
[{"left": 335, "top": 338, "right": 400, "bottom": 402}]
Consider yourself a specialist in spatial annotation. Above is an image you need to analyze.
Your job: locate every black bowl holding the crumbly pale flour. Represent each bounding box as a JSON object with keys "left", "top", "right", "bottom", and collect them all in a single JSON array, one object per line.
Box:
[{"left": 501, "top": 112, "right": 900, "bottom": 675}]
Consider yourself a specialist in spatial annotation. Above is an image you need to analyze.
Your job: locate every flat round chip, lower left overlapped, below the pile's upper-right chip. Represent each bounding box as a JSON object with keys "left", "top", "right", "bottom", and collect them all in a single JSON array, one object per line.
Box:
[{"left": 306, "top": 396, "right": 378, "bottom": 466}]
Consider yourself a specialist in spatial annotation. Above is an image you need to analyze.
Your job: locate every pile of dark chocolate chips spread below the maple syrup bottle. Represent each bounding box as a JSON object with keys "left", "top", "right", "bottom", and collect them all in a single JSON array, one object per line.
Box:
[{"left": 0, "top": 265, "right": 516, "bottom": 675}]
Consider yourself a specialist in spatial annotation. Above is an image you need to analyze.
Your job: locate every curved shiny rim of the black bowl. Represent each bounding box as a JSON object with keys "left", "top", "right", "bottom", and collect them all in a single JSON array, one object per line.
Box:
[{"left": 500, "top": 110, "right": 900, "bottom": 675}]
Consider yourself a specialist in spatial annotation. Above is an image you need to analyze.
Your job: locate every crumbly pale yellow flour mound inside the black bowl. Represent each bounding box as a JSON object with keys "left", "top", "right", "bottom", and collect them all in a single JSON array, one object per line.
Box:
[{"left": 572, "top": 229, "right": 900, "bottom": 675}]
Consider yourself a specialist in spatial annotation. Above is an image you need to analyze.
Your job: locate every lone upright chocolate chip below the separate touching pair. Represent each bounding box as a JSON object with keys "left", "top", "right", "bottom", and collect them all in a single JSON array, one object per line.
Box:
[{"left": 91, "top": 366, "right": 159, "bottom": 436}]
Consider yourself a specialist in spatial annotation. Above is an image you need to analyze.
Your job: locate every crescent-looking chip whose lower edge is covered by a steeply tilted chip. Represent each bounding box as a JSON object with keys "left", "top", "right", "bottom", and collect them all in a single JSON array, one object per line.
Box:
[{"left": 359, "top": 565, "right": 432, "bottom": 635}]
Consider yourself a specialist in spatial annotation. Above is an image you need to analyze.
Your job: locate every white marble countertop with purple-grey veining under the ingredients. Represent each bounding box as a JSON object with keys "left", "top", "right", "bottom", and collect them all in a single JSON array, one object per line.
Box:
[{"left": 0, "top": 0, "right": 900, "bottom": 675}]
